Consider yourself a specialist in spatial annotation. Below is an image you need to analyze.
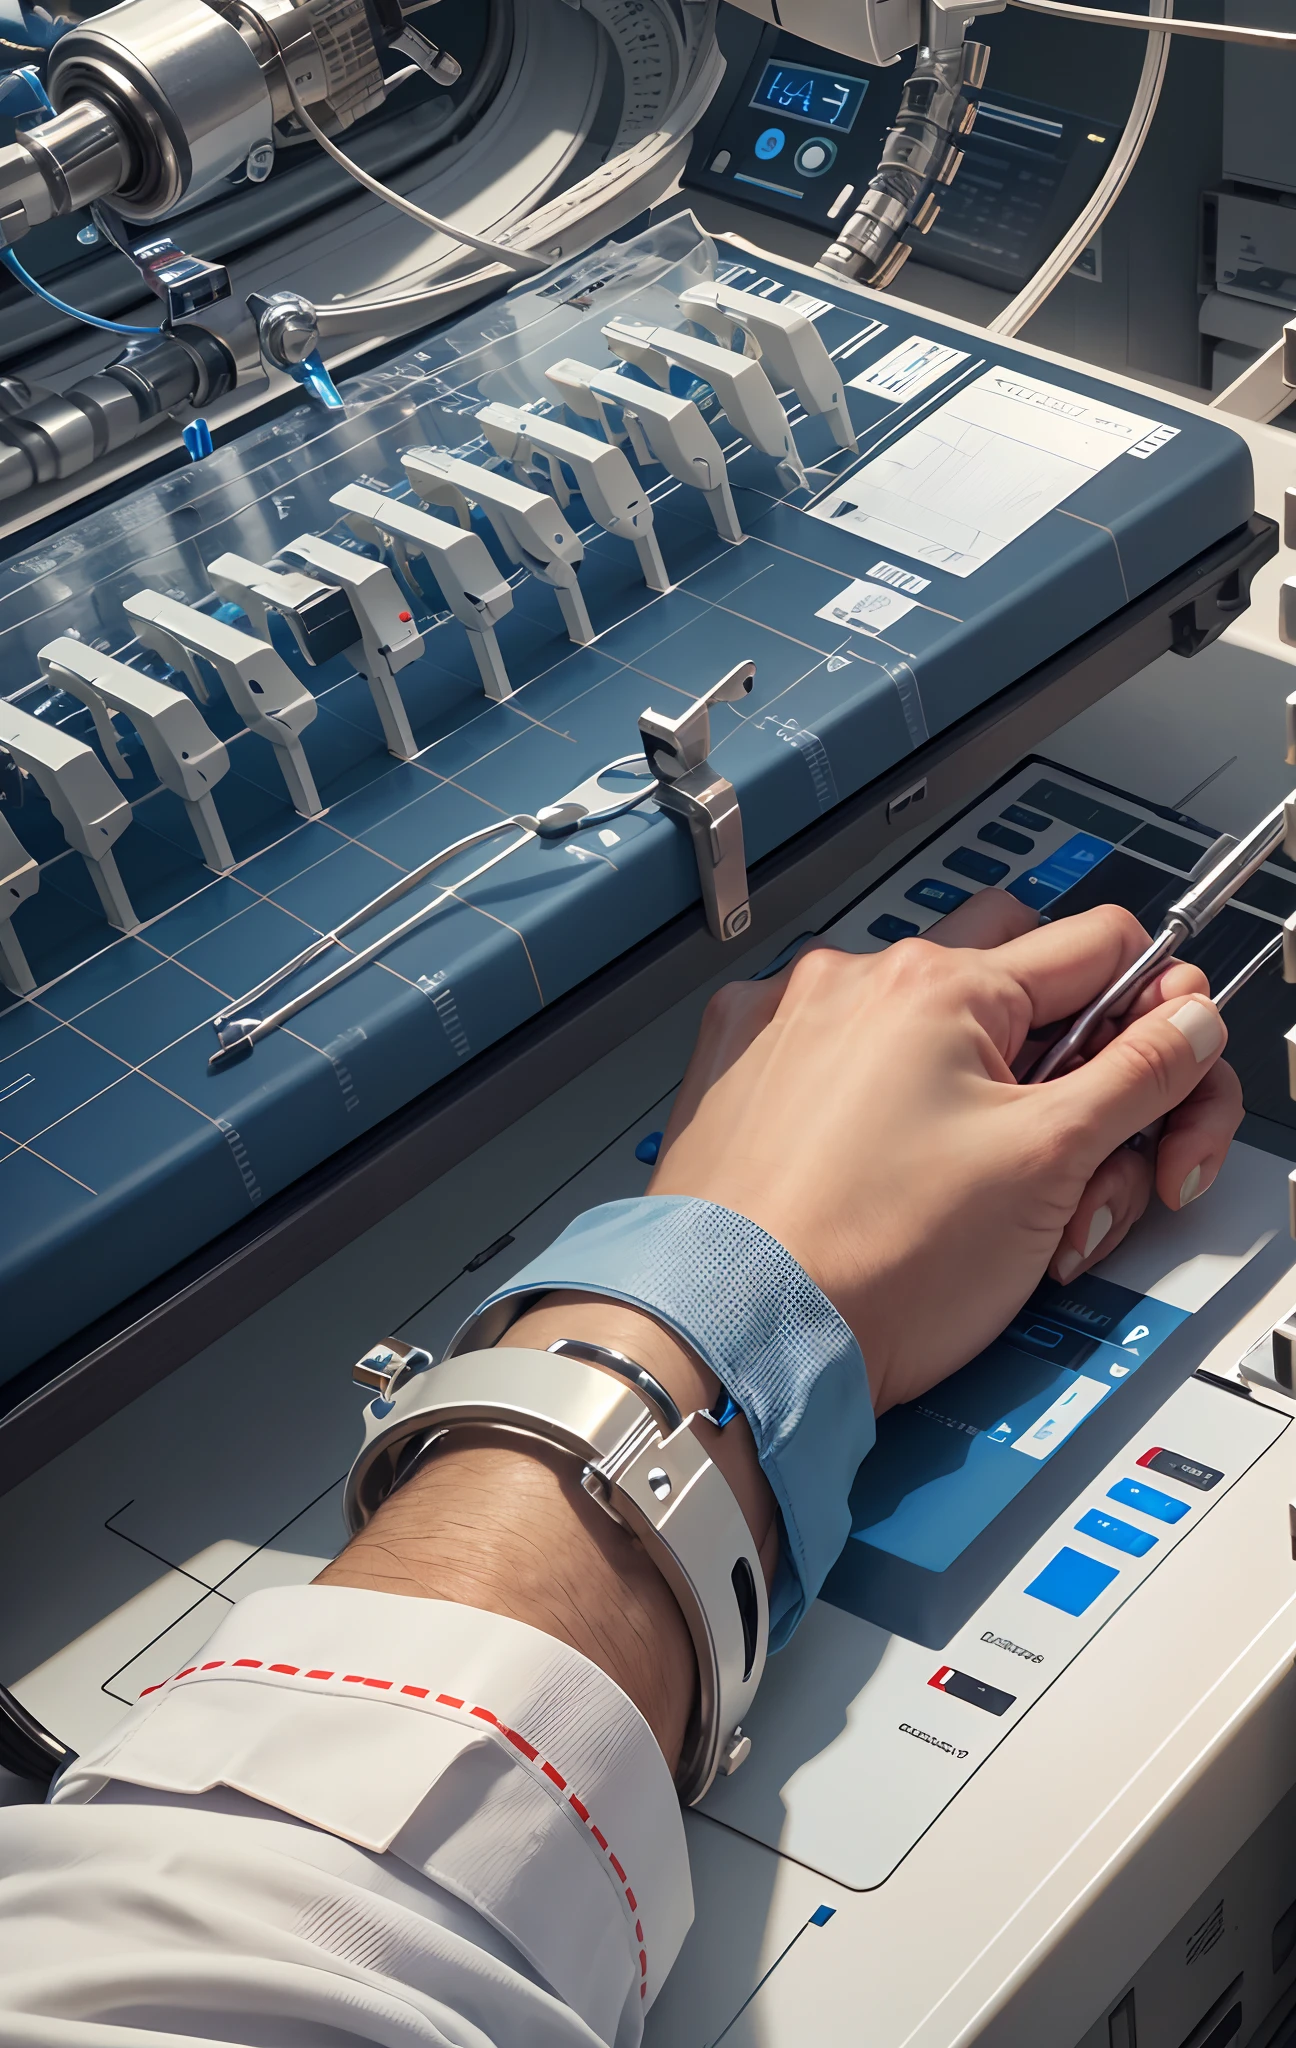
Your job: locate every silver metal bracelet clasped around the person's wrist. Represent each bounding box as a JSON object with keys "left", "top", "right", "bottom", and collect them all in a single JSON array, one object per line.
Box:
[{"left": 342, "top": 1337, "right": 770, "bottom": 1806}]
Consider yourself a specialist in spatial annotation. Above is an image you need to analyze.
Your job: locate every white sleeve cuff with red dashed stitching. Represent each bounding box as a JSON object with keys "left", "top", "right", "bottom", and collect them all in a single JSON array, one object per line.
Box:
[{"left": 53, "top": 1585, "right": 692, "bottom": 2042}]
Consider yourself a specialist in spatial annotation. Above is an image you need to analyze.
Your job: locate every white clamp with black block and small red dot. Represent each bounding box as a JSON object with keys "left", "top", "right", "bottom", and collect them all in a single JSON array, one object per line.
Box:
[{"left": 207, "top": 532, "right": 424, "bottom": 762}]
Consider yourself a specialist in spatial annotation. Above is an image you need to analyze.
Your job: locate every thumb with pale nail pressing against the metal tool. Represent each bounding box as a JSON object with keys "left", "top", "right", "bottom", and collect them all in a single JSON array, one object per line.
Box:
[{"left": 1044, "top": 995, "right": 1228, "bottom": 1171}]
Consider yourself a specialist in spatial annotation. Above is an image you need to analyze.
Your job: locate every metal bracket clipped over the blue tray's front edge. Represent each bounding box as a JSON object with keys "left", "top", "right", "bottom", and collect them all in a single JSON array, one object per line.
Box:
[{"left": 639, "top": 662, "right": 755, "bottom": 940}]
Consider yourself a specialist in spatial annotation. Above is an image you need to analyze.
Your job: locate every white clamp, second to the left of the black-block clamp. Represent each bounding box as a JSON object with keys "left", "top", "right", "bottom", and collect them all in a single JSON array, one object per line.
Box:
[{"left": 37, "top": 639, "right": 233, "bottom": 874}]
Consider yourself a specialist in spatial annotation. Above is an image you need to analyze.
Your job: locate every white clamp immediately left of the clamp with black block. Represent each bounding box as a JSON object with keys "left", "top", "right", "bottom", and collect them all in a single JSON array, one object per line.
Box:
[{"left": 123, "top": 590, "right": 321, "bottom": 817}]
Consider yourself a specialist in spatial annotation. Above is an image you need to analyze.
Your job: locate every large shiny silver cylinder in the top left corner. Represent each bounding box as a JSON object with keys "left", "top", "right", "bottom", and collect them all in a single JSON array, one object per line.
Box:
[{"left": 45, "top": 0, "right": 272, "bottom": 221}]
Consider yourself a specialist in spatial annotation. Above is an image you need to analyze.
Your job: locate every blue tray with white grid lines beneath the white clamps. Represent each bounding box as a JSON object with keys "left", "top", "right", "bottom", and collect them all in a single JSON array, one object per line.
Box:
[{"left": 0, "top": 215, "right": 1253, "bottom": 1378}]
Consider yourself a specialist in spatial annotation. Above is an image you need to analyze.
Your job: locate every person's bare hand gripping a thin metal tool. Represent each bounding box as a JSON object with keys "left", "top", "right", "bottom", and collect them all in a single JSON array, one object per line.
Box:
[{"left": 649, "top": 891, "right": 1243, "bottom": 1413}]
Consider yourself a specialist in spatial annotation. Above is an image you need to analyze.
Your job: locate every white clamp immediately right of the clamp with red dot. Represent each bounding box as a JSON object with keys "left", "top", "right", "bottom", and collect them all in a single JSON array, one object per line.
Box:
[{"left": 326, "top": 483, "right": 514, "bottom": 702}]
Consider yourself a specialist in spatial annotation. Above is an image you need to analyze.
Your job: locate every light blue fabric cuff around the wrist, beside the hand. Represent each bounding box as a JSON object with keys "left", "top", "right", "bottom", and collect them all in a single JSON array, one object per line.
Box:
[{"left": 450, "top": 1194, "right": 874, "bottom": 1649}]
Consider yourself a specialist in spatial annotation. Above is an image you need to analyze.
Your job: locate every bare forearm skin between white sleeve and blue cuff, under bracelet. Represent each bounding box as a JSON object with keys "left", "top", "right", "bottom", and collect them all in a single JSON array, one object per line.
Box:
[{"left": 319, "top": 1294, "right": 778, "bottom": 1769}]
